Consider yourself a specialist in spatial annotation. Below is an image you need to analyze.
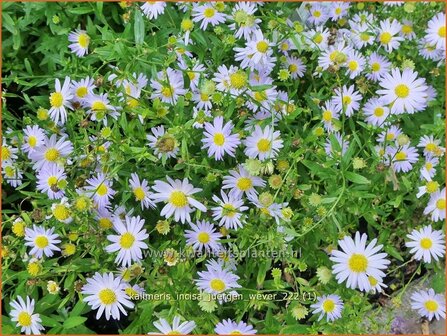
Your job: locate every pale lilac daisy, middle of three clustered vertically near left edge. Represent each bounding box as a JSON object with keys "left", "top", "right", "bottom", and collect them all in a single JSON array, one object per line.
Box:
[{"left": 28, "top": 134, "right": 73, "bottom": 170}]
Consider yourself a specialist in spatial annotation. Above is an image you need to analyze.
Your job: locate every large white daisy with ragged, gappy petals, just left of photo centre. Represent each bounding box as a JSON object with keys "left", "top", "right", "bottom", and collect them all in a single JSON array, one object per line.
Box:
[{"left": 151, "top": 176, "right": 206, "bottom": 223}]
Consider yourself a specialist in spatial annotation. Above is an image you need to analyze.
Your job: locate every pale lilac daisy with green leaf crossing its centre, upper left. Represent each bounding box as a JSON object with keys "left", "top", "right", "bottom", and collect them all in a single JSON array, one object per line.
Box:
[{"left": 151, "top": 68, "right": 186, "bottom": 105}]
